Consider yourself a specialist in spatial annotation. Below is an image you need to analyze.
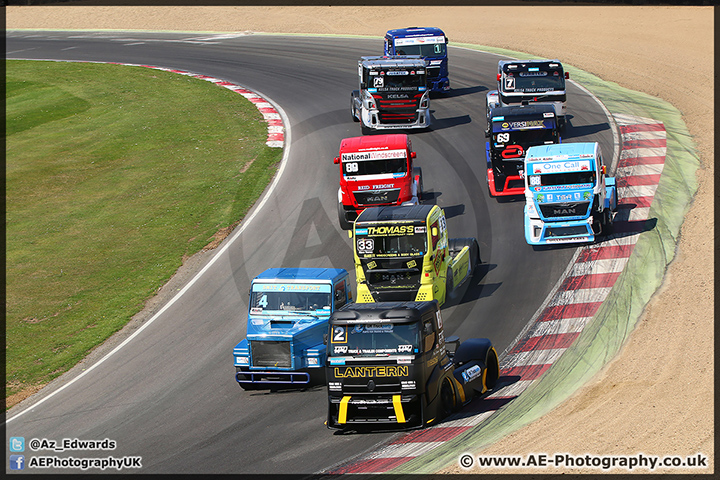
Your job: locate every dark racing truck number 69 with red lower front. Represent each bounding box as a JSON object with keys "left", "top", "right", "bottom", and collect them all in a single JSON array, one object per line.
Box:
[{"left": 485, "top": 104, "right": 562, "bottom": 197}]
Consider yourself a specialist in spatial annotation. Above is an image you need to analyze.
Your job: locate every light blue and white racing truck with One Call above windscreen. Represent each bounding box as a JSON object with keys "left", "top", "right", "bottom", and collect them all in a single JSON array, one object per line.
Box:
[{"left": 523, "top": 142, "right": 618, "bottom": 245}]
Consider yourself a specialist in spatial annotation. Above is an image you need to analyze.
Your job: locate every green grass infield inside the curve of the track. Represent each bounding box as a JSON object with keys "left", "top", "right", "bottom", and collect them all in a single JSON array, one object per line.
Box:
[{"left": 6, "top": 60, "right": 282, "bottom": 407}]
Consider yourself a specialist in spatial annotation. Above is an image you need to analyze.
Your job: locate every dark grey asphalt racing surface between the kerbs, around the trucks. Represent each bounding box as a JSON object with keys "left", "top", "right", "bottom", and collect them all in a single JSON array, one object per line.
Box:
[{"left": 6, "top": 31, "right": 614, "bottom": 474}]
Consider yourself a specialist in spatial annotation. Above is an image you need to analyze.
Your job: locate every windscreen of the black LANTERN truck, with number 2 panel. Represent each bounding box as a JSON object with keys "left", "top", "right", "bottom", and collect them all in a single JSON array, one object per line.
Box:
[{"left": 332, "top": 323, "right": 420, "bottom": 356}]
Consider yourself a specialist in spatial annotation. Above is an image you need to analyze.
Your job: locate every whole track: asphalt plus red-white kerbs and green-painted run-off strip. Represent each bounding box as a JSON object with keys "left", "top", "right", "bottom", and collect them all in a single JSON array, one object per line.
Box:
[{"left": 6, "top": 31, "right": 697, "bottom": 473}]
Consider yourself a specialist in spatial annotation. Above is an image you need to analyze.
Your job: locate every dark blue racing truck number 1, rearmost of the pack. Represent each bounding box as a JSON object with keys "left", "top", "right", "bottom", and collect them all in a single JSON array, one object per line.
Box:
[{"left": 385, "top": 27, "right": 450, "bottom": 92}]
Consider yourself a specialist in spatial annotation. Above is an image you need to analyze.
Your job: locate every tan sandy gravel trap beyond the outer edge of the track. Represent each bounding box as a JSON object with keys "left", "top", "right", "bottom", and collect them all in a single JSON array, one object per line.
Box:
[{"left": 6, "top": 2, "right": 714, "bottom": 473}]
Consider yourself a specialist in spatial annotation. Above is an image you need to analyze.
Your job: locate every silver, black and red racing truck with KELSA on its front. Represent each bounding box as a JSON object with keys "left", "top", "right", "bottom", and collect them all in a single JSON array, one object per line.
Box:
[{"left": 350, "top": 55, "right": 431, "bottom": 135}]
